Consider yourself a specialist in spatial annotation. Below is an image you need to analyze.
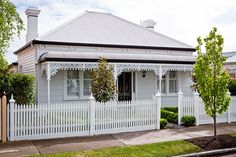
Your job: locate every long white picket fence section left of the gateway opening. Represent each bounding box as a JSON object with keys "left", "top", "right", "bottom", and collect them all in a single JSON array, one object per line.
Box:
[{"left": 9, "top": 97, "right": 160, "bottom": 141}]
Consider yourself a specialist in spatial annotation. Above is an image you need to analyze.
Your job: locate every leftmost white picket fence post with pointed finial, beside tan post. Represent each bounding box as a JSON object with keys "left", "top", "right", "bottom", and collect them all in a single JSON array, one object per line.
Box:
[{"left": 9, "top": 94, "right": 16, "bottom": 141}]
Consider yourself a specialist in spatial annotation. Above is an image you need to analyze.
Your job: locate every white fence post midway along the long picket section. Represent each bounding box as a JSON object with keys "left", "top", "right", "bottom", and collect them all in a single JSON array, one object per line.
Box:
[{"left": 88, "top": 93, "right": 95, "bottom": 136}]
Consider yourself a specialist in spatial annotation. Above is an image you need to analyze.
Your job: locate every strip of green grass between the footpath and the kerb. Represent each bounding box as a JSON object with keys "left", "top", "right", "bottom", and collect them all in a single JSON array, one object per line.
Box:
[{"left": 28, "top": 140, "right": 201, "bottom": 157}]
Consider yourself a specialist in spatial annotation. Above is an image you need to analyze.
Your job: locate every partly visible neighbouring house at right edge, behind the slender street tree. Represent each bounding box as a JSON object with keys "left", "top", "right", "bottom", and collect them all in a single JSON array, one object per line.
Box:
[{"left": 223, "top": 51, "right": 236, "bottom": 79}]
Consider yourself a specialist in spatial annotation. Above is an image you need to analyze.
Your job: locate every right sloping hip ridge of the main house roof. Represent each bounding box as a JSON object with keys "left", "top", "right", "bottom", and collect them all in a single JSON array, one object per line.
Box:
[{"left": 110, "top": 14, "right": 194, "bottom": 48}]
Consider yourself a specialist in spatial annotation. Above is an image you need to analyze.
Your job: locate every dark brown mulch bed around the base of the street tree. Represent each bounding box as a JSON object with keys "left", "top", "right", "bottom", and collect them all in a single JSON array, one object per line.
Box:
[{"left": 186, "top": 135, "right": 236, "bottom": 151}]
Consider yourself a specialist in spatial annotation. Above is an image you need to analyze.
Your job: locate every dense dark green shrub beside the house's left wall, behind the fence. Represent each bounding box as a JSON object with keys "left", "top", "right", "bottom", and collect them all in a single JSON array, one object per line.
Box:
[{"left": 10, "top": 74, "right": 34, "bottom": 104}]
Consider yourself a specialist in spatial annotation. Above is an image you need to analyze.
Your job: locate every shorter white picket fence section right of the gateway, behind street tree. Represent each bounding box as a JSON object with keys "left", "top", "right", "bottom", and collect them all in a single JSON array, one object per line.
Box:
[{"left": 178, "top": 92, "right": 236, "bottom": 125}]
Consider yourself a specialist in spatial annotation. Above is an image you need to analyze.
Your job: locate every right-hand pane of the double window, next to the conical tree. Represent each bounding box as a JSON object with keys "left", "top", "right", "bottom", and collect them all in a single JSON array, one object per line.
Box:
[{"left": 83, "top": 71, "right": 92, "bottom": 96}]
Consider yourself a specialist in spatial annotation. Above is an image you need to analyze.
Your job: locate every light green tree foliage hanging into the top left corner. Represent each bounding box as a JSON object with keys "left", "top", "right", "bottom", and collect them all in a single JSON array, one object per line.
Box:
[{"left": 0, "top": 0, "right": 24, "bottom": 54}]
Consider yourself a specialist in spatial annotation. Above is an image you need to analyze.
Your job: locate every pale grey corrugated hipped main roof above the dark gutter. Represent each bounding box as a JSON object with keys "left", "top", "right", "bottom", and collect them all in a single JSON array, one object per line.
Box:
[{"left": 38, "top": 11, "right": 193, "bottom": 48}]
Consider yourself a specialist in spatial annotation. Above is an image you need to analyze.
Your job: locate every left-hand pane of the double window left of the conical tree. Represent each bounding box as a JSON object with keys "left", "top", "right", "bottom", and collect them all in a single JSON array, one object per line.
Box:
[{"left": 66, "top": 70, "right": 80, "bottom": 97}]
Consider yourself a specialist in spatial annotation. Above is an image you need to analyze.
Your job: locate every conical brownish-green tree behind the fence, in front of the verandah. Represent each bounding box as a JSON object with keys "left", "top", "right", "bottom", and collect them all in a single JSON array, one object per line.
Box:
[{"left": 92, "top": 58, "right": 116, "bottom": 102}]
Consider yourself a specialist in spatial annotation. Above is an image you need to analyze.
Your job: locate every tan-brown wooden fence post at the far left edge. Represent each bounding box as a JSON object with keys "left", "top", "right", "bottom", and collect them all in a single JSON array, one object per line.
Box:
[{"left": 1, "top": 92, "right": 7, "bottom": 143}]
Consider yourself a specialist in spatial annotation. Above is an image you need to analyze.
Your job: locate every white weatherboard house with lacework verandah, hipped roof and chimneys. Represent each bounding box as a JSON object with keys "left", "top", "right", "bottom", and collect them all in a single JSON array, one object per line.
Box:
[{"left": 15, "top": 7, "right": 196, "bottom": 106}]
